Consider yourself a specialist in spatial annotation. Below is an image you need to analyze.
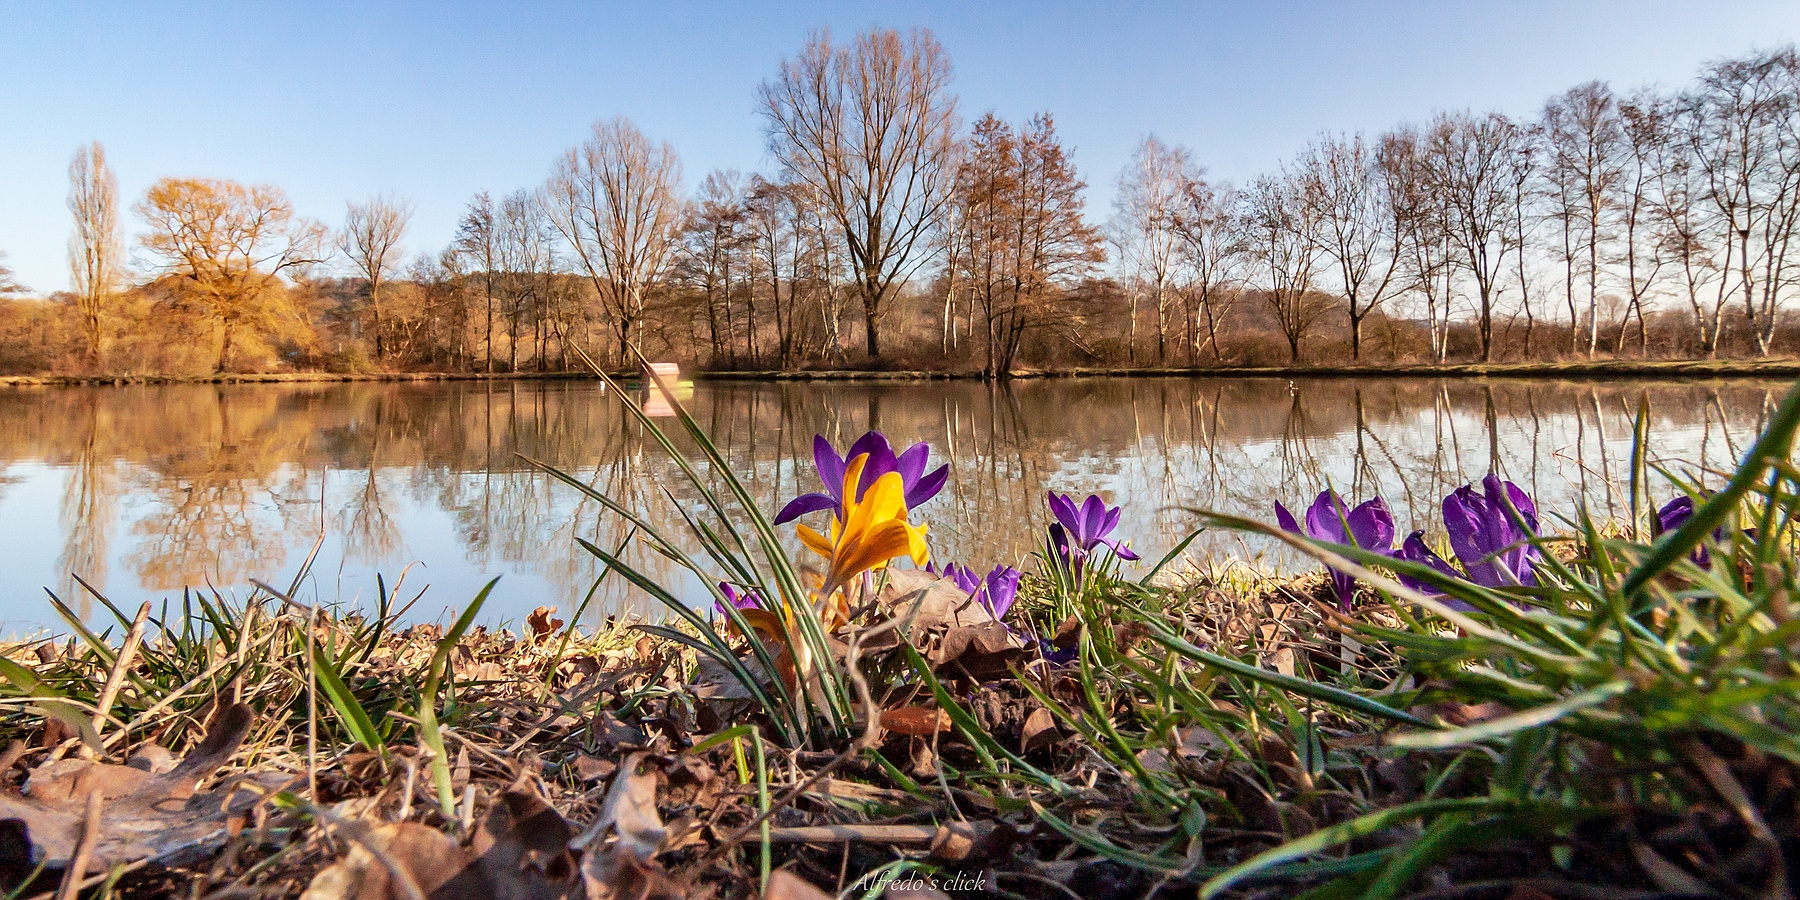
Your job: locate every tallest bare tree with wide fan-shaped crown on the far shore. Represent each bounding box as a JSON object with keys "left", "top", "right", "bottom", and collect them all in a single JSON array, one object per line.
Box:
[{"left": 758, "top": 29, "right": 958, "bottom": 356}]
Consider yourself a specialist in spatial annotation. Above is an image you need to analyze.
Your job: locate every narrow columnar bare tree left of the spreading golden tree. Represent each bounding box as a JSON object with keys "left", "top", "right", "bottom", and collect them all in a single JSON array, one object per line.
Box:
[{"left": 68, "top": 140, "right": 124, "bottom": 369}]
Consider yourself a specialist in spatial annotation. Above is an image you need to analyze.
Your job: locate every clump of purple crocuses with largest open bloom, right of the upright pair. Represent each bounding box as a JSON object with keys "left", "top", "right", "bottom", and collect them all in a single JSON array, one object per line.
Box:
[{"left": 1395, "top": 475, "right": 1543, "bottom": 592}]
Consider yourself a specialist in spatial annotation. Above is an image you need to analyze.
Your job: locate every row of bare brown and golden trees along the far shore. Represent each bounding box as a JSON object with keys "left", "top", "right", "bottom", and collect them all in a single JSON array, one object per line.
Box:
[{"left": 0, "top": 29, "right": 1800, "bottom": 374}]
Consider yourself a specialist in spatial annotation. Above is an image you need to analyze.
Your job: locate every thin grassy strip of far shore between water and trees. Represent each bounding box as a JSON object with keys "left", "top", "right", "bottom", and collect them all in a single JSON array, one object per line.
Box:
[{"left": 0, "top": 358, "right": 1800, "bottom": 387}]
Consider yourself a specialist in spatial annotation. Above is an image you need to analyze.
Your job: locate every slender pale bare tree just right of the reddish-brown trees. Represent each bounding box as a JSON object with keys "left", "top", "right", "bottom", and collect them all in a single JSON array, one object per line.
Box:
[{"left": 1107, "top": 135, "right": 1199, "bottom": 362}]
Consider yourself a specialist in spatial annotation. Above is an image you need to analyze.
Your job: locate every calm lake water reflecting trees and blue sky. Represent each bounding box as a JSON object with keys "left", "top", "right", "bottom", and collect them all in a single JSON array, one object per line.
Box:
[{"left": 0, "top": 378, "right": 1786, "bottom": 634}]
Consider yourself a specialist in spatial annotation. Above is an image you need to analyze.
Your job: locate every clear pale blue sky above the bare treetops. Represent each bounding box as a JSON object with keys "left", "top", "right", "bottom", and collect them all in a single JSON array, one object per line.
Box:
[{"left": 0, "top": 0, "right": 1800, "bottom": 292}]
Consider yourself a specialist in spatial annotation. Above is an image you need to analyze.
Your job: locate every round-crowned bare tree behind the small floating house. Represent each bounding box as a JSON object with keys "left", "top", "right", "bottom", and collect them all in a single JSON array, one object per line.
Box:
[{"left": 545, "top": 117, "right": 684, "bottom": 362}]
